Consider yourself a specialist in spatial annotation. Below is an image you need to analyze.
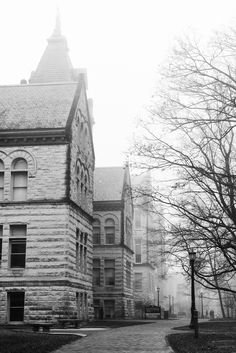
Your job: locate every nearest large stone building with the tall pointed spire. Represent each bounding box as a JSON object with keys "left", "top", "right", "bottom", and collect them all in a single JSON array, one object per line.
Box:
[{"left": 0, "top": 19, "right": 94, "bottom": 323}]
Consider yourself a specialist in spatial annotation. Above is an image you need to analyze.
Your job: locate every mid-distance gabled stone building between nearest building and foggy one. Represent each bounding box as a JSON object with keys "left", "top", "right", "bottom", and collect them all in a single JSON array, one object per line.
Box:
[{"left": 93, "top": 166, "right": 134, "bottom": 318}]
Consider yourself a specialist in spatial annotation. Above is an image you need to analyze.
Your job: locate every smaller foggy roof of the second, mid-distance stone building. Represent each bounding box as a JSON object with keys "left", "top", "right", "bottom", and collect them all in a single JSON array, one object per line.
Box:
[{"left": 94, "top": 167, "right": 126, "bottom": 201}]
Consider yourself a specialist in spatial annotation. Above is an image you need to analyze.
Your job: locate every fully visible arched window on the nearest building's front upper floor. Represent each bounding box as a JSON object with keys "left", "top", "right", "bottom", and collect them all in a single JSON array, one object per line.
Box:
[{"left": 11, "top": 158, "right": 28, "bottom": 201}]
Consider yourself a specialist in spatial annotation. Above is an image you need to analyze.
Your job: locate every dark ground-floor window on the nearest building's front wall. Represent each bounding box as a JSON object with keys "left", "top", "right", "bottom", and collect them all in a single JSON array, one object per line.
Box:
[{"left": 8, "top": 292, "right": 25, "bottom": 321}]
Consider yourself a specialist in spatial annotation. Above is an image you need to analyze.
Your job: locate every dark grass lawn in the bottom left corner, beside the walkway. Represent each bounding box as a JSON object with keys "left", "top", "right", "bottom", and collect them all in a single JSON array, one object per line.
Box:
[{"left": 0, "top": 329, "right": 79, "bottom": 353}]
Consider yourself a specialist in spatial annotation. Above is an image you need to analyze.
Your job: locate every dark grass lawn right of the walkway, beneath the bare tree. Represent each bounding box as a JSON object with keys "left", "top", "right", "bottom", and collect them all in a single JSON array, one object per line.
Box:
[{"left": 167, "top": 321, "right": 236, "bottom": 353}]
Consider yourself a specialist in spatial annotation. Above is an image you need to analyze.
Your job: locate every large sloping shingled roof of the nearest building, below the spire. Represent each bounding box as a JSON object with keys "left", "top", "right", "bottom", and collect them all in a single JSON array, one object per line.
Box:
[{"left": 0, "top": 82, "right": 78, "bottom": 130}]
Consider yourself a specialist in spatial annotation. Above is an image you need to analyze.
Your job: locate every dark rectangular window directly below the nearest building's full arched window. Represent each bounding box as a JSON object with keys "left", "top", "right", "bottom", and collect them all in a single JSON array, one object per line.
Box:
[{"left": 9, "top": 224, "right": 26, "bottom": 268}]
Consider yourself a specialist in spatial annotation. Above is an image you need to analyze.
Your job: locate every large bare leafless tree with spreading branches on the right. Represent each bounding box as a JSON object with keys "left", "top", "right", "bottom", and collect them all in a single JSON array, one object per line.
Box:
[{"left": 132, "top": 30, "right": 236, "bottom": 293}]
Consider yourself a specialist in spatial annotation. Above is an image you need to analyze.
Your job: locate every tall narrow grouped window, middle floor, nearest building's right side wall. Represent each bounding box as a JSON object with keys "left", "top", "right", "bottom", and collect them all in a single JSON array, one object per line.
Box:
[{"left": 76, "top": 229, "right": 88, "bottom": 274}]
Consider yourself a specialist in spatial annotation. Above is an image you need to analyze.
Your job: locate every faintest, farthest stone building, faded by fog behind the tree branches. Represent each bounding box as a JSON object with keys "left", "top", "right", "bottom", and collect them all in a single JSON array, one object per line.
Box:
[{"left": 132, "top": 174, "right": 165, "bottom": 317}]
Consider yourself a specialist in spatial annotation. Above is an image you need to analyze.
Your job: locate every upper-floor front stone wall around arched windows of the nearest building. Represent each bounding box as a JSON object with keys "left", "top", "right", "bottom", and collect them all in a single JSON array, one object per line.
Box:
[{"left": 0, "top": 144, "right": 68, "bottom": 202}]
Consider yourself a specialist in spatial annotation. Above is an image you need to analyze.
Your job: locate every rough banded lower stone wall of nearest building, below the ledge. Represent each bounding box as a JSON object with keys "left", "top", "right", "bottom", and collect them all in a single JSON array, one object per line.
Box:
[{"left": 0, "top": 203, "right": 93, "bottom": 322}]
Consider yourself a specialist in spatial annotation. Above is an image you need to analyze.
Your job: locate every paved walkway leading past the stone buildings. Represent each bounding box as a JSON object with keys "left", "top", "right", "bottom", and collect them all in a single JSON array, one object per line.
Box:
[{"left": 54, "top": 320, "right": 186, "bottom": 353}]
